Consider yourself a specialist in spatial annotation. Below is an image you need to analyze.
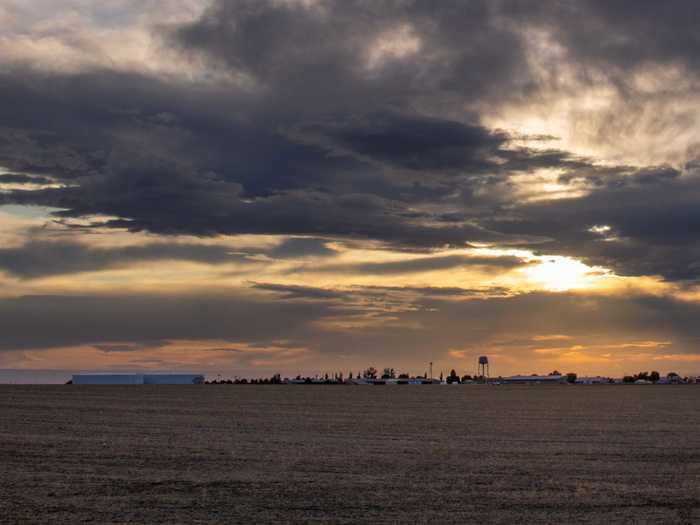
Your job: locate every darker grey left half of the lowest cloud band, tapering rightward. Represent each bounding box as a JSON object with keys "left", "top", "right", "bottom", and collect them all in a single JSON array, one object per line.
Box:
[{"left": 0, "top": 291, "right": 347, "bottom": 350}]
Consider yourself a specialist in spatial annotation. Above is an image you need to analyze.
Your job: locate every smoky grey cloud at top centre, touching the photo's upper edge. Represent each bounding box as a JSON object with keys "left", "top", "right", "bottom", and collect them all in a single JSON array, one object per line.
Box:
[{"left": 172, "top": 0, "right": 528, "bottom": 108}]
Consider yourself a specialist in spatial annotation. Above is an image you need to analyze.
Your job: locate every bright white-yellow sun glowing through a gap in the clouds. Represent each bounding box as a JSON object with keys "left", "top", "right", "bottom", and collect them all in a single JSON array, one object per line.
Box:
[{"left": 523, "top": 255, "right": 604, "bottom": 292}]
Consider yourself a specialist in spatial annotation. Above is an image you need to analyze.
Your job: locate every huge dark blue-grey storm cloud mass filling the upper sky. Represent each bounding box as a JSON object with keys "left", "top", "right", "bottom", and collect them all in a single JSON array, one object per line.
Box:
[{"left": 0, "top": 0, "right": 700, "bottom": 279}]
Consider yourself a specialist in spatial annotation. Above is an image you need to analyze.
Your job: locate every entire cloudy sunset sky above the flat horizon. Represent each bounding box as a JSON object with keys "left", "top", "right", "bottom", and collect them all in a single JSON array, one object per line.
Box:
[{"left": 0, "top": 0, "right": 700, "bottom": 382}]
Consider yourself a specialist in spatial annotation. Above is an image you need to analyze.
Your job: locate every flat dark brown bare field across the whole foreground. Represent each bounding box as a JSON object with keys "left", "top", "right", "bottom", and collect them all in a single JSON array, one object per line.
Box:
[{"left": 0, "top": 385, "right": 700, "bottom": 524}]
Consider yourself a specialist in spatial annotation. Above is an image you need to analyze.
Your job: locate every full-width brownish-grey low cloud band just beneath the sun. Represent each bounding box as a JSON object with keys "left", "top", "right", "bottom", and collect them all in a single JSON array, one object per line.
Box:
[{"left": 5, "top": 289, "right": 700, "bottom": 366}]
